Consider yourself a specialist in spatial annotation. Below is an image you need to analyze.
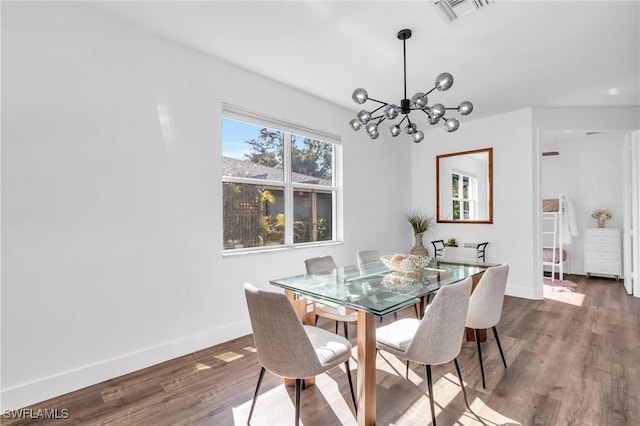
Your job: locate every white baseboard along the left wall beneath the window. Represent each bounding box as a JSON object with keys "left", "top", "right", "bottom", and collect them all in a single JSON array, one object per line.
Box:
[{"left": 0, "top": 321, "right": 251, "bottom": 412}]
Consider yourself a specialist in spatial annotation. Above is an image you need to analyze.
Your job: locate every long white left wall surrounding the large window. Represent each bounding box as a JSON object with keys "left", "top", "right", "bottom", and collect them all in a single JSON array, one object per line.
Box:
[{"left": 1, "top": 2, "right": 413, "bottom": 409}]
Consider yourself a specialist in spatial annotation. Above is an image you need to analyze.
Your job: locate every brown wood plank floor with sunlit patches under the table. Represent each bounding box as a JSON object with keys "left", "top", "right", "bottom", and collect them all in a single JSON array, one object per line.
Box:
[{"left": 2, "top": 275, "right": 640, "bottom": 426}]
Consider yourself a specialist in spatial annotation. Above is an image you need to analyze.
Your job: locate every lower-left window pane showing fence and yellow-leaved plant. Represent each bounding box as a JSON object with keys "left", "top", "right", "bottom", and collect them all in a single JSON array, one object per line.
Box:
[{"left": 223, "top": 183, "right": 284, "bottom": 249}]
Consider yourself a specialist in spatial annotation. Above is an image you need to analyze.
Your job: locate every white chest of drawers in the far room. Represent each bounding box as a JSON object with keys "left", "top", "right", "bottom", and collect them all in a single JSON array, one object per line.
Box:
[{"left": 584, "top": 228, "right": 622, "bottom": 280}]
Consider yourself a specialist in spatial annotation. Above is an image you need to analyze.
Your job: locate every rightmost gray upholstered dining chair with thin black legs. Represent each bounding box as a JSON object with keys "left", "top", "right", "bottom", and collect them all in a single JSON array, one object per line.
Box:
[{"left": 465, "top": 264, "right": 509, "bottom": 389}]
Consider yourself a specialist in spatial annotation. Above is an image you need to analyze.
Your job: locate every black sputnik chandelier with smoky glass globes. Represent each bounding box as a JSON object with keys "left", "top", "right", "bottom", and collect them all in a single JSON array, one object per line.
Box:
[{"left": 349, "top": 29, "right": 473, "bottom": 143}]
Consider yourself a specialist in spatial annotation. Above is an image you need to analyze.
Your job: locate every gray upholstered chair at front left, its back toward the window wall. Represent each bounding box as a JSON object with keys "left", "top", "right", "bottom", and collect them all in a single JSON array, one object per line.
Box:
[{"left": 244, "top": 284, "right": 356, "bottom": 425}]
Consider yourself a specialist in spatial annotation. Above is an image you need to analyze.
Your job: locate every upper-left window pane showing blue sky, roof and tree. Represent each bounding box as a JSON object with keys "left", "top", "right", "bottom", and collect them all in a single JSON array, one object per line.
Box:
[{"left": 222, "top": 118, "right": 284, "bottom": 182}]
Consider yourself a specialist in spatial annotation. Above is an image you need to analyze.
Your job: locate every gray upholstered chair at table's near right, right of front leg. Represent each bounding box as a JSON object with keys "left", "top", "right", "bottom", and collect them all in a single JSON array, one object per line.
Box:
[{"left": 376, "top": 277, "right": 471, "bottom": 426}]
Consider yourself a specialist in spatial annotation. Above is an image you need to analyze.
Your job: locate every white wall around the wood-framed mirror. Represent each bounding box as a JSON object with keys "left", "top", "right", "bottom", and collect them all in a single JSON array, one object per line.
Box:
[{"left": 411, "top": 109, "right": 541, "bottom": 298}]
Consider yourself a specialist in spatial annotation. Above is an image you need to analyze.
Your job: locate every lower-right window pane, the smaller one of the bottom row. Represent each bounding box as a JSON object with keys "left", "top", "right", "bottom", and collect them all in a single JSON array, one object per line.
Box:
[{"left": 293, "top": 190, "right": 333, "bottom": 243}]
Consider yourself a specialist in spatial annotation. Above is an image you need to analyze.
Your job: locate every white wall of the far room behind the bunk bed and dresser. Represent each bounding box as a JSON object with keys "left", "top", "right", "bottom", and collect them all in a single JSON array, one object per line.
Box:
[{"left": 540, "top": 132, "right": 624, "bottom": 274}]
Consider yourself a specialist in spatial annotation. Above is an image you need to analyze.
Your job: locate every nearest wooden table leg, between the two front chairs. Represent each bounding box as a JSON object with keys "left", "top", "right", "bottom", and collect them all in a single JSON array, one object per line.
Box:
[{"left": 356, "top": 311, "right": 377, "bottom": 426}]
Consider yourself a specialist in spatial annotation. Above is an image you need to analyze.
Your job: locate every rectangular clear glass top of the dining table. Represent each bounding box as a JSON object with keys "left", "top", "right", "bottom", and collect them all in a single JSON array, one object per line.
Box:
[{"left": 270, "top": 258, "right": 494, "bottom": 316}]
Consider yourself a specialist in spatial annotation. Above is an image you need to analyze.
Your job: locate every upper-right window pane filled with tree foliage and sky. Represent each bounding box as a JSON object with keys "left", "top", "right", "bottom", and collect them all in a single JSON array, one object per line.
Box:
[{"left": 291, "top": 135, "right": 333, "bottom": 186}]
